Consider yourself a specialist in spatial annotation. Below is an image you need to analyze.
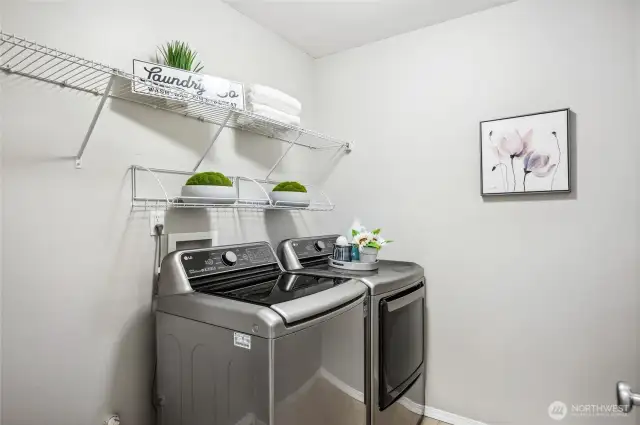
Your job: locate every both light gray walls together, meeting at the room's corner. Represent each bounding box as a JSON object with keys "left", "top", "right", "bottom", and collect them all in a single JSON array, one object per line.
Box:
[{"left": 0, "top": 0, "right": 640, "bottom": 425}]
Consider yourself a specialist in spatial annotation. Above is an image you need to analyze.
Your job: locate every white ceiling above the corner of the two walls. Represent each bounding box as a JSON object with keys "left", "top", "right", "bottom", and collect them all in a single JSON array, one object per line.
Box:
[{"left": 225, "top": 0, "right": 515, "bottom": 58}]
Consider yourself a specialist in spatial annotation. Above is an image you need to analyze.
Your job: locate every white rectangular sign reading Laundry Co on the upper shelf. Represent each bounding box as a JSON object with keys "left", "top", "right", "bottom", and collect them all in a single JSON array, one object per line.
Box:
[{"left": 133, "top": 59, "right": 244, "bottom": 110}]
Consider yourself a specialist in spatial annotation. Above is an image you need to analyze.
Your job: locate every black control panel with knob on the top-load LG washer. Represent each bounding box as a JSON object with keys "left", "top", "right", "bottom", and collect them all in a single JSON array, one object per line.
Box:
[{"left": 180, "top": 243, "right": 277, "bottom": 279}]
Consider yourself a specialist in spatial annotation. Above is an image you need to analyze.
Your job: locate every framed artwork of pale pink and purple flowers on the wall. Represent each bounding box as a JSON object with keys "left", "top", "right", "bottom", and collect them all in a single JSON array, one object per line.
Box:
[{"left": 480, "top": 109, "right": 571, "bottom": 196}]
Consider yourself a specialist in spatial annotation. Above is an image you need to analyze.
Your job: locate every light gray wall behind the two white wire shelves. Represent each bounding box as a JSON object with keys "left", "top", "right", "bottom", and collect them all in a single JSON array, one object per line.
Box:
[{"left": 0, "top": 0, "right": 330, "bottom": 425}]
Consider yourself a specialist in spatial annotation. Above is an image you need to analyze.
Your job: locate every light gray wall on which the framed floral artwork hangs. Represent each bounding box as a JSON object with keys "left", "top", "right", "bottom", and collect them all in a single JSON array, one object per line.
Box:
[{"left": 317, "top": 0, "right": 639, "bottom": 425}]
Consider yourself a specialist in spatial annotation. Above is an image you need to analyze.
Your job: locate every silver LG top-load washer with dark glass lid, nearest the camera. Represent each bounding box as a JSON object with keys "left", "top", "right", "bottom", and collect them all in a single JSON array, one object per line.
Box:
[{"left": 156, "top": 242, "right": 367, "bottom": 425}]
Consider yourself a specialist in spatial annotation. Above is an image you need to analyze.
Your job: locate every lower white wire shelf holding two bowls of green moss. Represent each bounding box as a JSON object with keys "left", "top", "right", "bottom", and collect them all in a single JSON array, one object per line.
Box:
[{"left": 131, "top": 165, "right": 335, "bottom": 211}]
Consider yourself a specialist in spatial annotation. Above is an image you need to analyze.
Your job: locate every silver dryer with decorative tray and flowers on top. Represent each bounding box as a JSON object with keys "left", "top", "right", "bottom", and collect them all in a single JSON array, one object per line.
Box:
[{"left": 278, "top": 235, "right": 426, "bottom": 425}]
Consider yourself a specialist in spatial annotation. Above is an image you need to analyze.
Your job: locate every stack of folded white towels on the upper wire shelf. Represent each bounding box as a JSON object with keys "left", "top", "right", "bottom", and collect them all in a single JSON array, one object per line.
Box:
[{"left": 246, "top": 84, "right": 302, "bottom": 126}]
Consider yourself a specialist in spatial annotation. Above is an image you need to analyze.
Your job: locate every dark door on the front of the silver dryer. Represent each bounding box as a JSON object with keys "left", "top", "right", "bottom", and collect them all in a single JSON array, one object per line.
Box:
[{"left": 379, "top": 284, "right": 425, "bottom": 410}]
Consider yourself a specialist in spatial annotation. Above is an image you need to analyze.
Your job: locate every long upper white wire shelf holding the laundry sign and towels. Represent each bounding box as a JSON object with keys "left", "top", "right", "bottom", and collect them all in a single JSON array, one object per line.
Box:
[{"left": 0, "top": 32, "right": 352, "bottom": 168}]
